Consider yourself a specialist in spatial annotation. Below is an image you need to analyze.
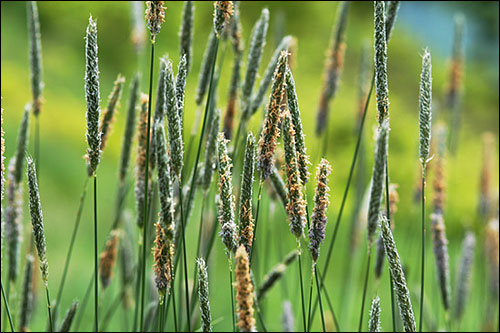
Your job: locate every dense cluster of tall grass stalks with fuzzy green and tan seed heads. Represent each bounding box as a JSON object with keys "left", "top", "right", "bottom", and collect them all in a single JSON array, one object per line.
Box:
[{"left": 1, "top": 1, "right": 499, "bottom": 332}]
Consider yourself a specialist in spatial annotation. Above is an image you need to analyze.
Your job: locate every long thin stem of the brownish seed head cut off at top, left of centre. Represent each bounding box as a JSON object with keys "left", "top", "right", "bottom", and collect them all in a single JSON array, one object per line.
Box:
[{"left": 139, "top": 41, "right": 155, "bottom": 331}]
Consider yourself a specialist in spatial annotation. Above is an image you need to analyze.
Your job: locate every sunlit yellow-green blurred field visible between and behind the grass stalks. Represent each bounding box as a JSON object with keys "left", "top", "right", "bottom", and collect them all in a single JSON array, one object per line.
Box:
[{"left": 1, "top": 1, "right": 499, "bottom": 331}]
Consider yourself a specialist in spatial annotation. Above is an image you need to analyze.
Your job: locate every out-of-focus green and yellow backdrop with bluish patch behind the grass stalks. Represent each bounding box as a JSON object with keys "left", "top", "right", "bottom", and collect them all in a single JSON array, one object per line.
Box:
[{"left": 1, "top": 1, "right": 499, "bottom": 330}]
